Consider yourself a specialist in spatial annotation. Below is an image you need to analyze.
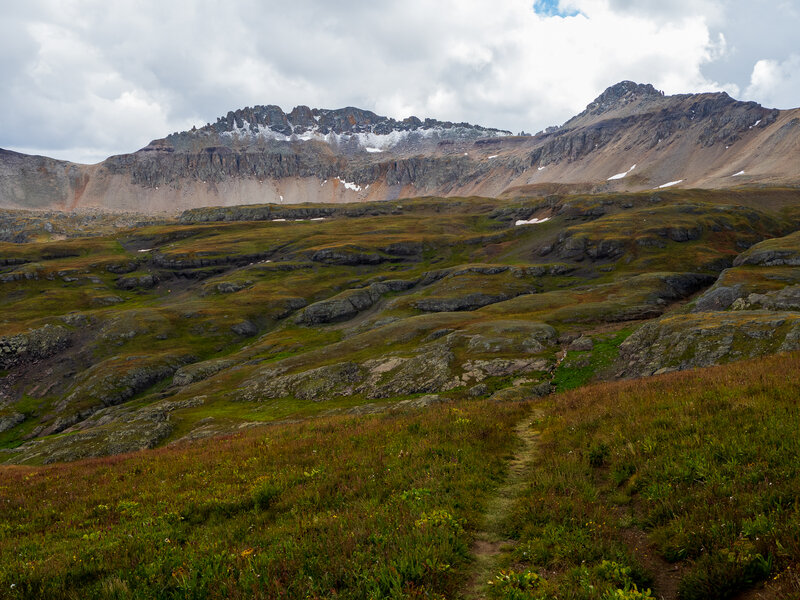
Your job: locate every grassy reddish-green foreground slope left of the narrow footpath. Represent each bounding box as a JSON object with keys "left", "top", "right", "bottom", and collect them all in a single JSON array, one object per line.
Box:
[{"left": 0, "top": 403, "right": 522, "bottom": 599}]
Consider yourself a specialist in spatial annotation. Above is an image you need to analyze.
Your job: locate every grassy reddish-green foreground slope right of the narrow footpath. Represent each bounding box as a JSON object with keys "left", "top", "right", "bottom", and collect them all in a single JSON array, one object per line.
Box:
[{"left": 490, "top": 354, "right": 800, "bottom": 599}]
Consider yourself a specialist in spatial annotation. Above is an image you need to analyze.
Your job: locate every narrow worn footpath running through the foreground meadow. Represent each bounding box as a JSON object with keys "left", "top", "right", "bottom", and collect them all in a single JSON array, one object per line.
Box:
[{"left": 464, "top": 408, "right": 544, "bottom": 600}]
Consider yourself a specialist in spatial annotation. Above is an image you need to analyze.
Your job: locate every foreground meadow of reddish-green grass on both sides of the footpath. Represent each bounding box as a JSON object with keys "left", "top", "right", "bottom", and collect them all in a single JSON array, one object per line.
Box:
[{"left": 0, "top": 354, "right": 800, "bottom": 600}]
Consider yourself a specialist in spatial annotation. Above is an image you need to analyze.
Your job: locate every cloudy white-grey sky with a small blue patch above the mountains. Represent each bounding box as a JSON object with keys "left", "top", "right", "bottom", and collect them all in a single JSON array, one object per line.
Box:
[{"left": 0, "top": 0, "right": 800, "bottom": 163}]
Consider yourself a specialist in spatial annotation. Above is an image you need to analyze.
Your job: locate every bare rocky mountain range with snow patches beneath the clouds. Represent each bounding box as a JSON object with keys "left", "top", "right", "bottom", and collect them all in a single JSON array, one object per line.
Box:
[{"left": 0, "top": 81, "right": 800, "bottom": 212}]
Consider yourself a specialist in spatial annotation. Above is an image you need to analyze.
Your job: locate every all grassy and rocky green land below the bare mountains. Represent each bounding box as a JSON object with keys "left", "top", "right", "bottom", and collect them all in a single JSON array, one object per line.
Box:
[{"left": 0, "top": 189, "right": 800, "bottom": 600}]
